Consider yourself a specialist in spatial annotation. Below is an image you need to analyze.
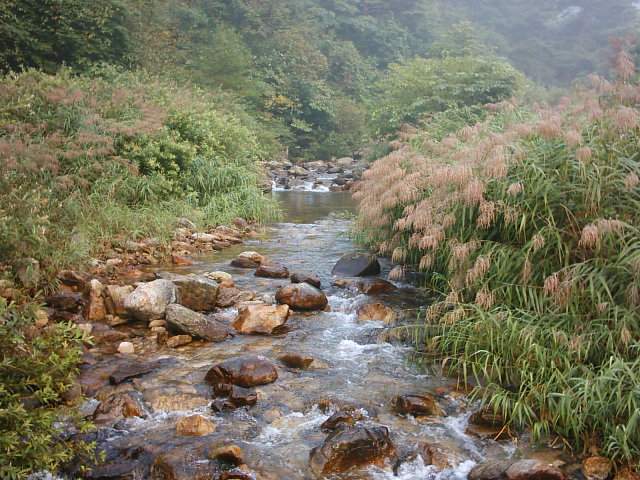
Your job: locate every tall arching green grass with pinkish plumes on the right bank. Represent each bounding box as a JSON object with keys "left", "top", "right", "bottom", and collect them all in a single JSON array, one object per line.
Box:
[{"left": 356, "top": 47, "right": 640, "bottom": 467}]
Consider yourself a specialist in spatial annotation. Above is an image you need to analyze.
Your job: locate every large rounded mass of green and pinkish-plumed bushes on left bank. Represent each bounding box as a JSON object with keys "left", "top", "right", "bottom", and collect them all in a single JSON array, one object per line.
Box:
[{"left": 0, "top": 68, "right": 276, "bottom": 288}]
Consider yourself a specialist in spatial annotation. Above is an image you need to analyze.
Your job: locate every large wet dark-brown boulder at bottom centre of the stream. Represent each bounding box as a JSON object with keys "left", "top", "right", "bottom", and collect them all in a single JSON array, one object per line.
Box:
[{"left": 310, "top": 426, "right": 395, "bottom": 476}]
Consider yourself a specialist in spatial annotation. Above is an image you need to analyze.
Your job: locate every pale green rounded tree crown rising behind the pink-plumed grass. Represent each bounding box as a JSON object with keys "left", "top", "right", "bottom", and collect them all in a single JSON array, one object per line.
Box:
[{"left": 371, "top": 56, "right": 524, "bottom": 134}]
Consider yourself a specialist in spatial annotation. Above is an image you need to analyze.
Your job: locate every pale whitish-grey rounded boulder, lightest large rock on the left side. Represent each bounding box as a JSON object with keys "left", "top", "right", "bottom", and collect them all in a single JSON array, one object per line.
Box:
[{"left": 124, "top": 279, "right": 176, "bottom": 322}]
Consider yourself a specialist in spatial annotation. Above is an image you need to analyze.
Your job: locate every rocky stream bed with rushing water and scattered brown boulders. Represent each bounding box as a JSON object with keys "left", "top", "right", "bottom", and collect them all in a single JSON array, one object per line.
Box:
[{"left": 36, "top": 192, "right": 596, "bottom": 480}]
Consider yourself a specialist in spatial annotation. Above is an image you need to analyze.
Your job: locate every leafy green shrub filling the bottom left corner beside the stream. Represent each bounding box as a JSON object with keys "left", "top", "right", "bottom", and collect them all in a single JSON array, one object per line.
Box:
[{"left": 0, "top": 298, "right": 91, "bottom": 480}]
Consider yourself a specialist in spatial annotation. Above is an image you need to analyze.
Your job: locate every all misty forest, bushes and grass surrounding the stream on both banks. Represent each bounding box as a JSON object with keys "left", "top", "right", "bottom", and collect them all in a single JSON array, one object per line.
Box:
[{"left": 0, "top": 0, "right": 640, "bottom": 480}]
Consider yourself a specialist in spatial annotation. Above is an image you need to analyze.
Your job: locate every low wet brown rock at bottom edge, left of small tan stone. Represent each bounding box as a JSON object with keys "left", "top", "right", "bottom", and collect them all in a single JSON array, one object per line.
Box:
[{"left": 151, "top": 447, "right": 220, "bottom": 480}]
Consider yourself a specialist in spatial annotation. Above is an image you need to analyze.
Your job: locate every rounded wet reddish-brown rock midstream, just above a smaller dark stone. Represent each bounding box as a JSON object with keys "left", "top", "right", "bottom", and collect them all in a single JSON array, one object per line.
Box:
[{"left": 205, "top": 355, "right": 278, "bottom": 388}]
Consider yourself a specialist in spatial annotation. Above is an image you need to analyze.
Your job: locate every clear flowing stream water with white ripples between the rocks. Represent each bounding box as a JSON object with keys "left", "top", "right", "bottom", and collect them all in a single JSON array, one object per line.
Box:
[{"left": 80, "top": 192, "right": 532, "bottom": 480}]
